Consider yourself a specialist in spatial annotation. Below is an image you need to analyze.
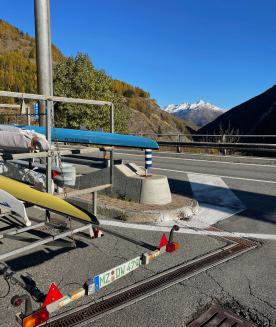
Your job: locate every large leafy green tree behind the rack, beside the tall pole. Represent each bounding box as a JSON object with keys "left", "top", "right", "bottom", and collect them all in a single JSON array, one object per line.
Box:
[{"left": 54, "top": 53, "right": 127, "bottom": 132}]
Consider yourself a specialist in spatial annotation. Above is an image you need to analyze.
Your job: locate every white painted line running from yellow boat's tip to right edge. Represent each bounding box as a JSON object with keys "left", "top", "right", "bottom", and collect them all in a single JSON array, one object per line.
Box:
[{"left": 99, "top": 220, "right": 276, "bottom": 241}]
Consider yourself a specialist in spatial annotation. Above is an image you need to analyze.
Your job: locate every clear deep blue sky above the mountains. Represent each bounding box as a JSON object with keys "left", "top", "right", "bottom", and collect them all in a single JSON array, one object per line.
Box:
[{"left": 0, "top": 0, "right": 276, "bottom": 108}]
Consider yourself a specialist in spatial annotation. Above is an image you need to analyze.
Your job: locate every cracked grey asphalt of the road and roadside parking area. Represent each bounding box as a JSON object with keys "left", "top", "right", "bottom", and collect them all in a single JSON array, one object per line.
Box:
[{"left": 0, "top": 150, "right": 276, "bottom": 327}]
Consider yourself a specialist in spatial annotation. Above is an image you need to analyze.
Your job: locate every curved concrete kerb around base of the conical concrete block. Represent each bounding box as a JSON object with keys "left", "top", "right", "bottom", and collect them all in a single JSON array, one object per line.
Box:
[{"left": 70, "top": 198, "right": 199, "bottom": 223}]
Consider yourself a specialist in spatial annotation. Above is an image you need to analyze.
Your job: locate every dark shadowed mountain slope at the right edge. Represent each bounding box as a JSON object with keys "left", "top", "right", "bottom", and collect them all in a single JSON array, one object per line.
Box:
[{"left": 198, "top": 85, "right": 276, "bottom": 135}]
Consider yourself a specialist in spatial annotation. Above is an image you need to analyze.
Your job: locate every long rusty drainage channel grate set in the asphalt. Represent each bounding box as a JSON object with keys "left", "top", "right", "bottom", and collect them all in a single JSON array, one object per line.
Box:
[{"left": 42, "top": 234, "right": 257, "bottom": 327}]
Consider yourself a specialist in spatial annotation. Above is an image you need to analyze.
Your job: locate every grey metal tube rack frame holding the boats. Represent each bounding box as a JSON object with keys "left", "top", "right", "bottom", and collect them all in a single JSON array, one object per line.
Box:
[{"left": 0, "top": 91, "right": 114, "bottom": 260}]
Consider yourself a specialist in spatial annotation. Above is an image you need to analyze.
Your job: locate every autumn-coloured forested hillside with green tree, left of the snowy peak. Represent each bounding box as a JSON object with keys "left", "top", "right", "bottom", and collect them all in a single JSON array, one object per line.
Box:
[{"left": 0, "top": 20, "right": 193, "bottom": 133}]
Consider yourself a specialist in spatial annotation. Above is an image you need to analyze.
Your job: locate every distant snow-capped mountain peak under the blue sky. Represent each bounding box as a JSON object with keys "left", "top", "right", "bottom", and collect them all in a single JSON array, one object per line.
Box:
[{"left": 164, "top": 100, "right": 223, "bottom": 127}]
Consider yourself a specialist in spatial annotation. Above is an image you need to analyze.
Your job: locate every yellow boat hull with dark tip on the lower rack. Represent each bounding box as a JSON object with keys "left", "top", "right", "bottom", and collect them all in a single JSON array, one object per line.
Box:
[{"left": 0, "top": 176, "right": 98, "bottom": 223}]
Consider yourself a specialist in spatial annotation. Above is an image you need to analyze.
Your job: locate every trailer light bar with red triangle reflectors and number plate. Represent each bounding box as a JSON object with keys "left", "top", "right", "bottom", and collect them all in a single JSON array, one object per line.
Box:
[{"left": 0, "top": 225, "right": 180, "bottom": 327}]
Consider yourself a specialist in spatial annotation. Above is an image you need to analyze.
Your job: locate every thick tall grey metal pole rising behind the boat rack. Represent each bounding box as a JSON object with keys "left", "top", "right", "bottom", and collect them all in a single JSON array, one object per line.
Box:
[{"left": 34, "top": 0, "right": 53, "bottom": 126}]
